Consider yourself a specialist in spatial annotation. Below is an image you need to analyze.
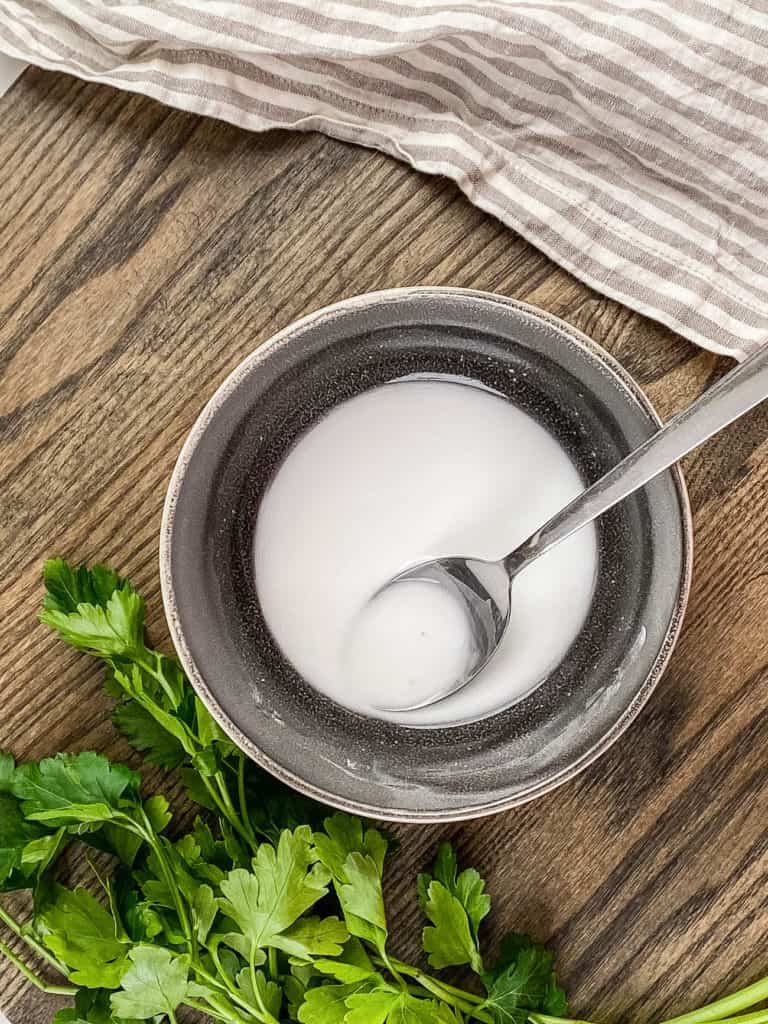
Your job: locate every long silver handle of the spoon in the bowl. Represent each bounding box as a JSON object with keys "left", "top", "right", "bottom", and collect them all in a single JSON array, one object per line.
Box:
[{"left": 504, "top": 344, "right": 768, "bottom": 574}]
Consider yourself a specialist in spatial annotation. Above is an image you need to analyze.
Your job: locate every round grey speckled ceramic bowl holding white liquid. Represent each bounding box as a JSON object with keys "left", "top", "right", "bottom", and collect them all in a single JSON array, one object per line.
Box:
[{"left": 161, "top": 288, "right": 691, "bottom": 821}]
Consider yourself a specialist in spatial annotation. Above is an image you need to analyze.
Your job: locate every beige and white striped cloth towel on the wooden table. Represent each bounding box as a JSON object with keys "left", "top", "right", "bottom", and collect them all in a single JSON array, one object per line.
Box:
[{"left": 0, "top": 0, "right": 768, "bottom": 357}]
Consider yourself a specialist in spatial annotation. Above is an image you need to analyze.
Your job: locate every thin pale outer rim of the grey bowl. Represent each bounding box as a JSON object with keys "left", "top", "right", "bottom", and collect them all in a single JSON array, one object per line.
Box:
[{"left": 159, "top": 286, "right": 693, "bottom": 824}]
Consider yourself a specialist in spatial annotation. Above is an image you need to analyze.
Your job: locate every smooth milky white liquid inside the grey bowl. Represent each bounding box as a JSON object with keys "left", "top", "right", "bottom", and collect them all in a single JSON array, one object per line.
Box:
[{"left": 254, "top": 379, "right": 597, "bottom": 725}]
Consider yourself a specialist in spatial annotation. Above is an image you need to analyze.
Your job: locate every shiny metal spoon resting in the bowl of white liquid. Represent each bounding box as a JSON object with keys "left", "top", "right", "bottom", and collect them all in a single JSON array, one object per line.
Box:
[{"left": 378, "top": 344, "right": 768, "bottom": 712}]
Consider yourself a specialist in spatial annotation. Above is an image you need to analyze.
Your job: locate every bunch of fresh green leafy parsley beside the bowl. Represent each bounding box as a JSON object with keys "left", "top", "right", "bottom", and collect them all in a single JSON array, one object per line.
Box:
[{"left": 0, "top": 559, "right": 768, "bottom": 1024}]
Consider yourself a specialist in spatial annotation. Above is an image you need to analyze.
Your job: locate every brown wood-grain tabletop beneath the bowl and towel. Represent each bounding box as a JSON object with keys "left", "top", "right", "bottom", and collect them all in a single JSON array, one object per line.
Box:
[{"left": 0, "top": 70, "right": 768, "bottom": 1024}]
